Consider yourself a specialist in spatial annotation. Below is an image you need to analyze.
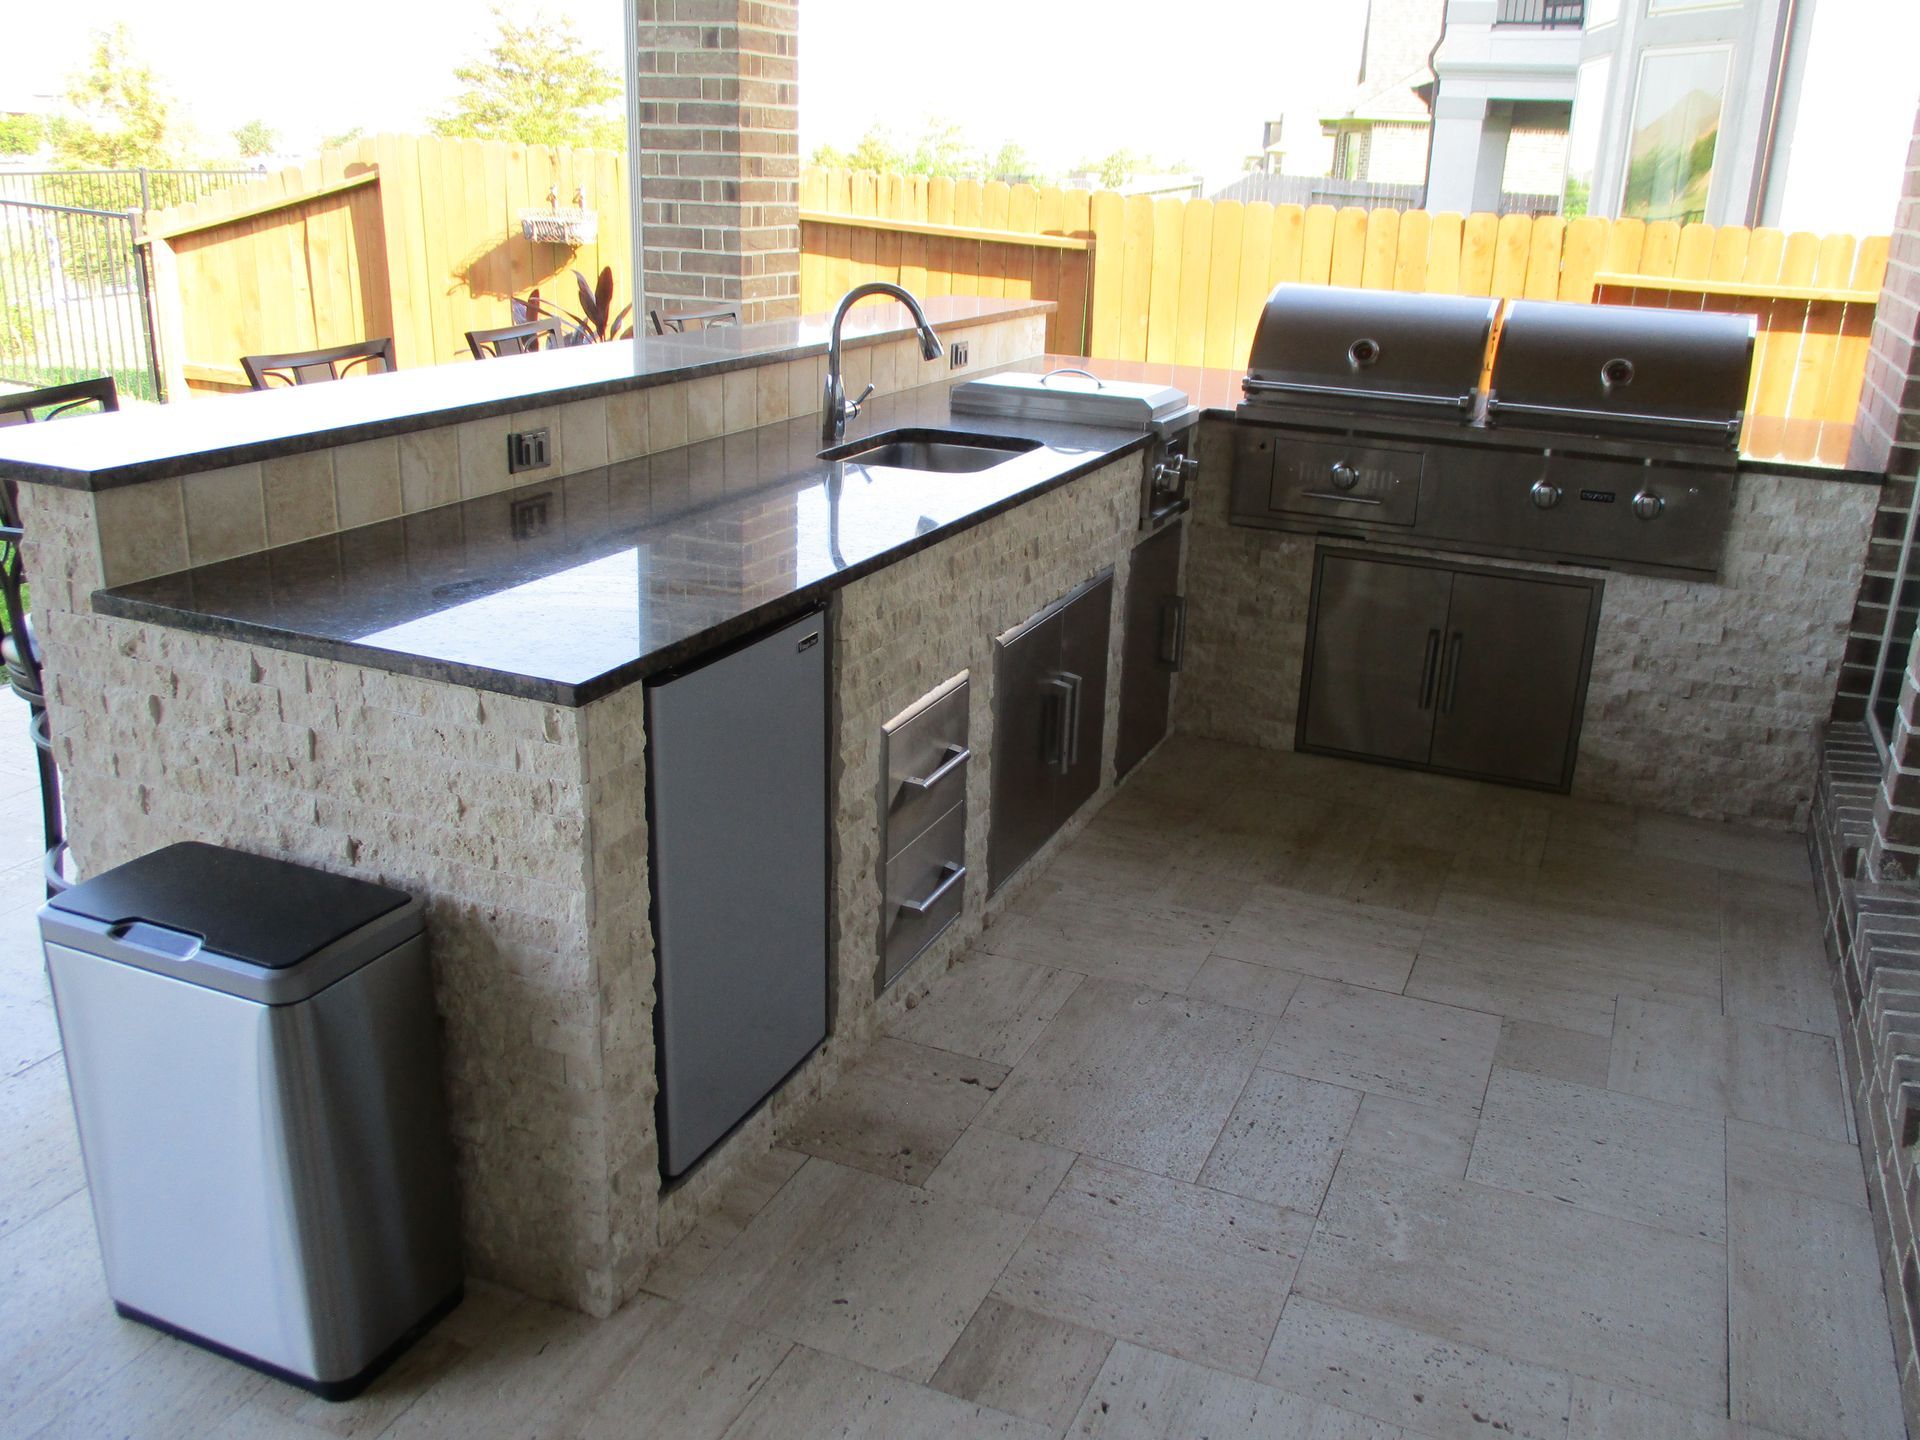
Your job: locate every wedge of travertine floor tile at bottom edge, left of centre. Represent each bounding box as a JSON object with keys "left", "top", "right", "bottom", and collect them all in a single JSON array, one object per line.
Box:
[{"left": 726, "top": 1346, "right": 1052, "bottom": 1440}]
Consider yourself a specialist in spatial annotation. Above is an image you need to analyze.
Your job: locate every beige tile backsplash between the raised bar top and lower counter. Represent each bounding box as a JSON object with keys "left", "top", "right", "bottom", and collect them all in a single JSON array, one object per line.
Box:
[{"left": 98, "top": 317, "right": 1044, "bottom": 586}]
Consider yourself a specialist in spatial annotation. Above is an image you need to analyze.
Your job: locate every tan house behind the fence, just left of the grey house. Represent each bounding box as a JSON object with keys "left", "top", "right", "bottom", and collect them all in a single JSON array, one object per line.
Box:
[{"left": 1321, "top": 0, "right": 1446, "bottom": 186}]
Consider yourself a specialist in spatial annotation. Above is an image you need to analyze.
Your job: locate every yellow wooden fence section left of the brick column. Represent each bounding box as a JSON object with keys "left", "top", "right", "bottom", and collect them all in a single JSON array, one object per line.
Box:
[{"left": 142, "top": 136, "right": 632, "bottom": 396}]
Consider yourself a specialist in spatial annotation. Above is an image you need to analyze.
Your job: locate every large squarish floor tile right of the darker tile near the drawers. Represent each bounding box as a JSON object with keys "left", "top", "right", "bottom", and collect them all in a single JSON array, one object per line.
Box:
[{"left": 979, "top": 979, "right": 1273, "bottom": 1181}]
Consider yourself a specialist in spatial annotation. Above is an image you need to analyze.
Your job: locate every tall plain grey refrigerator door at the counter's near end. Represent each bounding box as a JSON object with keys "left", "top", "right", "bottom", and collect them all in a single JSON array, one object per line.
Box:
[{"left": 647, "top": 614, "right": 828, "bottom": 1177}]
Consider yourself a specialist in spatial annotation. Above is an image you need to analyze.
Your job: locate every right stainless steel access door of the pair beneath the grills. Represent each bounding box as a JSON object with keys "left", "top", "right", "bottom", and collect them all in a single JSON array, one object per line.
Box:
[{"left": 1430, "top": 572, "right": 1594, "bottom": 787}]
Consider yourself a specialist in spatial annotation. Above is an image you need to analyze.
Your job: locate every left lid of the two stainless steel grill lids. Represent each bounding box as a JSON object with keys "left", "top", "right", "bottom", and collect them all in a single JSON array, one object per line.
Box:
[{"left": 1244, "top": 284, "right": 1500, "bottom": 424}]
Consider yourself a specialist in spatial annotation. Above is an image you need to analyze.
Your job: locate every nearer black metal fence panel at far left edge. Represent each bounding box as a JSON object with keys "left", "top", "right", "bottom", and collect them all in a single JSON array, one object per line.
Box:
[{"left": 0, "top": 200, "right": 165, "bottom": 399}]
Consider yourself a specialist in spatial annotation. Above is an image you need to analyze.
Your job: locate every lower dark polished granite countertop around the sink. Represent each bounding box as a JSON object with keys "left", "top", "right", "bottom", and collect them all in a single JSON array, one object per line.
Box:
[{"left": 94, "top": 384, "right": 1146, "bottom": 705}]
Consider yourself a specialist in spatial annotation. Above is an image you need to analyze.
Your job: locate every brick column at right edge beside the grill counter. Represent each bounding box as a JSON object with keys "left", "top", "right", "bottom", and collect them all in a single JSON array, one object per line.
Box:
[{"left": 1834, "top": 98, "right": 1920, "bottom": 879}]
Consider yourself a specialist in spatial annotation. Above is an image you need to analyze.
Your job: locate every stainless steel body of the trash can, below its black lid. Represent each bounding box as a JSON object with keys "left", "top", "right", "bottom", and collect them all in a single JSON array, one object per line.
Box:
[{"left": 46, "top": 937, "right": 461, "bottom": 1382}]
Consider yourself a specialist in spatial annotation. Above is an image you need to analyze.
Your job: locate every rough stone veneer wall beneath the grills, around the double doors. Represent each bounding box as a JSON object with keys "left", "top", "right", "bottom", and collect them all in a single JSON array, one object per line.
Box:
[{"left": 1179, "top": 424, "right": 1878, "bottom": 828}]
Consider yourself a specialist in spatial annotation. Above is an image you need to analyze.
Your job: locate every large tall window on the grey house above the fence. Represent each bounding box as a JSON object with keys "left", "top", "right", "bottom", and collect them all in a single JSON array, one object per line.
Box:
[{"left": 1620, "top": 46, "right": 1728, "bottom": 225}]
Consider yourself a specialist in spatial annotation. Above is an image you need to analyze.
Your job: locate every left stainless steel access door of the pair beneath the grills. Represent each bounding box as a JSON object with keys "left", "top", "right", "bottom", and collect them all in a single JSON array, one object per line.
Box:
[{"left": 1300, "top": 553, "right": 1453, "bottom": 764}]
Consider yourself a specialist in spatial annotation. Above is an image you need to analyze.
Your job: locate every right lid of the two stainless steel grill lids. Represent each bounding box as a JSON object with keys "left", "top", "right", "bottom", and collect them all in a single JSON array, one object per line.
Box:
[{"left": 1486, "top": 300, "right": 1755, "bottom": 449}]
